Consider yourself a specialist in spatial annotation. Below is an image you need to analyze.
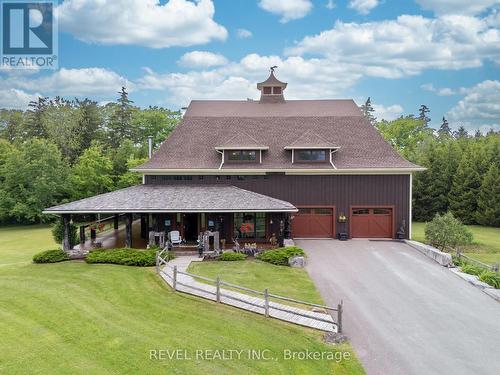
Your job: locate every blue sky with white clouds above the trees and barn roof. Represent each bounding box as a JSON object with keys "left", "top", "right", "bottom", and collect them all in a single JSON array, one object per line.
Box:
[{"left": 0, "top": 0, "right": 500, "bottom": 131}]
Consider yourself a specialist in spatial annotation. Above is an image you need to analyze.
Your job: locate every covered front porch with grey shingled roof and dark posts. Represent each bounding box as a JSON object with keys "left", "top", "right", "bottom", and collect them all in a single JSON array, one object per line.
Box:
[{"left": 44, "top": 185, "right": 297, "bottom": 251}]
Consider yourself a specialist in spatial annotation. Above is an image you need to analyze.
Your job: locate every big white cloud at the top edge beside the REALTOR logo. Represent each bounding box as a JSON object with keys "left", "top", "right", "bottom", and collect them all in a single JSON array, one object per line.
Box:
[{"left": 56, "top": 0, "right": 227, "bottom": 48}]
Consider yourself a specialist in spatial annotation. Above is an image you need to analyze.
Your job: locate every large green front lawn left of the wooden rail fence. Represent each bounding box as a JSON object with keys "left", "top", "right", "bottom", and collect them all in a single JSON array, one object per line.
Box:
[{"left": 0, "top": 226, "right": 364, "bottom": 375}]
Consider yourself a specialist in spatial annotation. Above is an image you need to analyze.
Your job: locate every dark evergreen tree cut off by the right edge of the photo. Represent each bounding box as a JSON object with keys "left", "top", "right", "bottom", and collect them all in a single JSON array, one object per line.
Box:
[{"left": 476, "top": 164, "right": 500, "bottom": 227}]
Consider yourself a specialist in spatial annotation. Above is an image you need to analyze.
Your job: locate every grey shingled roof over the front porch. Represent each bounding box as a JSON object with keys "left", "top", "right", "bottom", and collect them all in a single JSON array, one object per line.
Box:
[{"left": 43, "top": 184, "right": 297, "bottom": 214}]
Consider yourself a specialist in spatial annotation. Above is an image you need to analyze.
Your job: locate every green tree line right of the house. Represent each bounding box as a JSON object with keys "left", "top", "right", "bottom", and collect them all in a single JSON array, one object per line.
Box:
[{"left": 361, "top": 98, "right": 500, "bottom": 227}]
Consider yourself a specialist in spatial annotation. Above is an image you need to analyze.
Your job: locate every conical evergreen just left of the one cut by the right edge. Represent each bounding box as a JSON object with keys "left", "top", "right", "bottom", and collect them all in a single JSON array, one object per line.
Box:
[{"left": 449, "top": 150, "right": 481, "bottom": 224}]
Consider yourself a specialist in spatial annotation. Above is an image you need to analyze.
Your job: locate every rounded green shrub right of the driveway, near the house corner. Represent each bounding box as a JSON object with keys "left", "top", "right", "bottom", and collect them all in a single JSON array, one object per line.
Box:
[{"left": 425, "top": 212, "right": 472, "bottom": 250}]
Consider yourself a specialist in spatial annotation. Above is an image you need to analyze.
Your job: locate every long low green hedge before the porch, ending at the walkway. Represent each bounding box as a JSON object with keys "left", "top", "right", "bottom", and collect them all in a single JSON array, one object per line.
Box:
[{"left": 85, "top": 248, "right": 156, "bottom": 267}]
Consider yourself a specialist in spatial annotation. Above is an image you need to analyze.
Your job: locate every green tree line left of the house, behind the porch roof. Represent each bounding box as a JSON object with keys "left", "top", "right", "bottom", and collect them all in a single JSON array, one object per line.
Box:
[{"left": 0, "top": 87, "right": 181, "bottom": 223}]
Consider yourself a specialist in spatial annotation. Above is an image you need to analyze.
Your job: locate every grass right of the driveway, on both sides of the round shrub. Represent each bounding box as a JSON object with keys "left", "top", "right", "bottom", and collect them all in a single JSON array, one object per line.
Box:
[{"left": 412, "top": 222, "right": 500, "bottom": 264}]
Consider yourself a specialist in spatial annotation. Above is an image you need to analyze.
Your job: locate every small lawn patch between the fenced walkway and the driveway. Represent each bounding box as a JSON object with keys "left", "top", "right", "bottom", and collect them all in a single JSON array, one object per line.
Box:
[{"left": 188, "top": 260, "right": 323, "bottom": 304}]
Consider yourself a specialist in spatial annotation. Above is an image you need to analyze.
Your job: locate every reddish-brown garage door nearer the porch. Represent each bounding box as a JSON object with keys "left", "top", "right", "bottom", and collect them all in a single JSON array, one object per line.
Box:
[{"left": 292, "top": 208, "right": 333, "bottom": 238}]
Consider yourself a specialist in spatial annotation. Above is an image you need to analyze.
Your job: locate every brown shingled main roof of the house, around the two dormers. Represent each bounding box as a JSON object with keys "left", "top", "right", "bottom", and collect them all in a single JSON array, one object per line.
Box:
[{"left": 134, "top": 100, "right": 422, "bottom": 173}]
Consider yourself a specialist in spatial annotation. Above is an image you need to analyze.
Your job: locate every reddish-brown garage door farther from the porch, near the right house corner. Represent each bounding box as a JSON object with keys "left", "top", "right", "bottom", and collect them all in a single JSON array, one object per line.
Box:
[{"left": 351, "top": 207, "right": 393, "bottom": 238}]
